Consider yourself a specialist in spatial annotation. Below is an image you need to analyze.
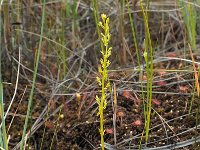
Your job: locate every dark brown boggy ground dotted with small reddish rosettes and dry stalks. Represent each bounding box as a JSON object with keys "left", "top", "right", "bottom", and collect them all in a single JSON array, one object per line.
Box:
[{"left": 3, "top": 50, "right": 200, "bottom": 150}]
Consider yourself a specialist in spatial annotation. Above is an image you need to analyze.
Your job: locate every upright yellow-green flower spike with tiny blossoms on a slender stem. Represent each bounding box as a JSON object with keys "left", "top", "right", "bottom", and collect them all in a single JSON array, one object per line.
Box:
[{"left": 96, "top": 14, "right": 112, "bottom": 150}]
